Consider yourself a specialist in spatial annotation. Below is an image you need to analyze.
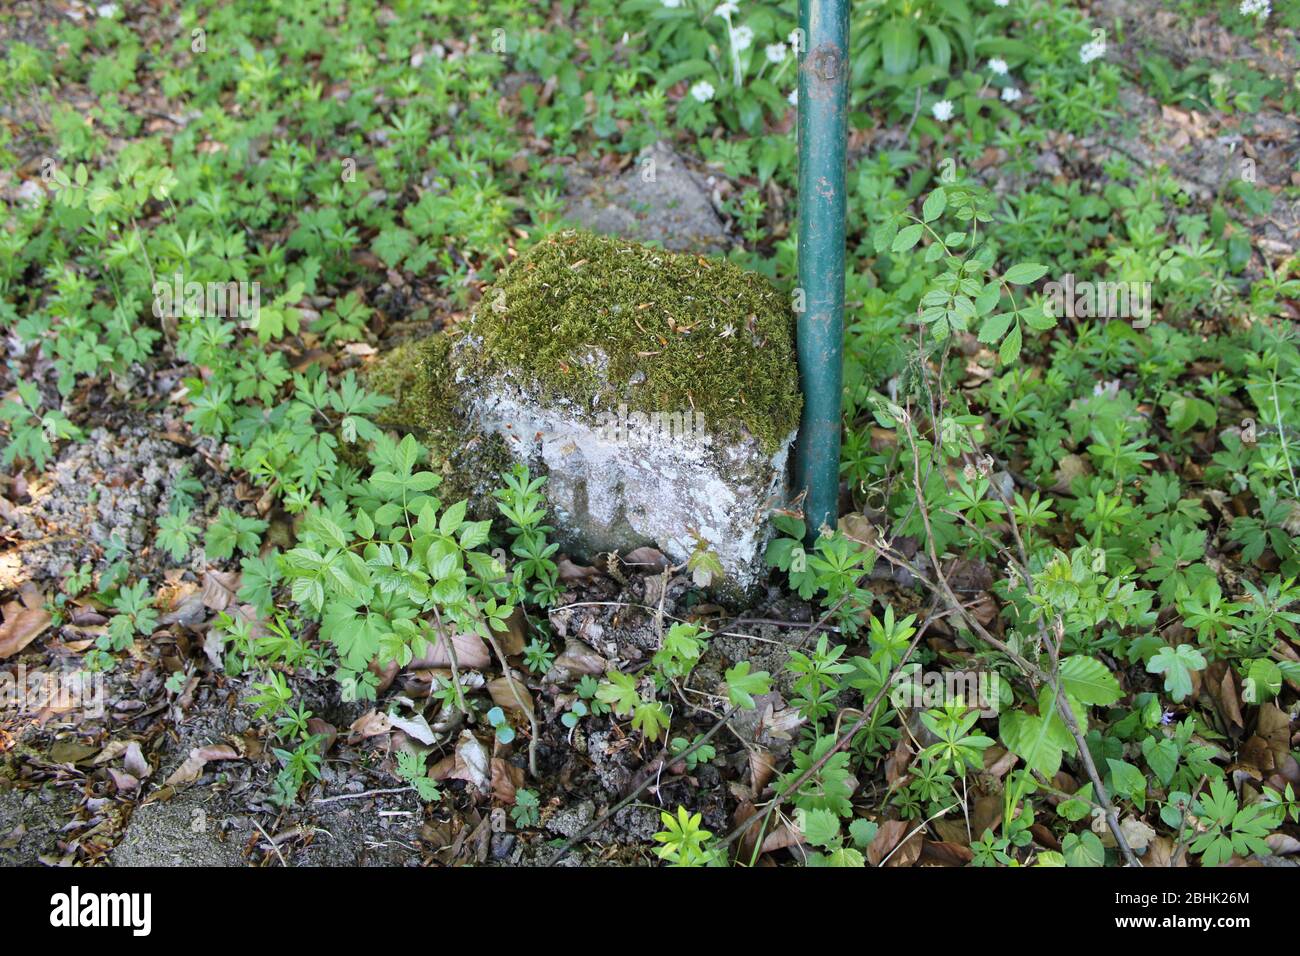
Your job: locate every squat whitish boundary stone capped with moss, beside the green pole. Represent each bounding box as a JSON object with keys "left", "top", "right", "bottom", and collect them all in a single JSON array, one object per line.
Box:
[{"left": 369, "top": 232, "right": 800, "bottom": 591}]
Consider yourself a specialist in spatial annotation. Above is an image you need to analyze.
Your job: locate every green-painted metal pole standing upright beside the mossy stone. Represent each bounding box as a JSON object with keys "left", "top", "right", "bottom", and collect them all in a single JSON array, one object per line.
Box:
[{"left": 794, "top": 0, "right": 850, "bottom": 535}]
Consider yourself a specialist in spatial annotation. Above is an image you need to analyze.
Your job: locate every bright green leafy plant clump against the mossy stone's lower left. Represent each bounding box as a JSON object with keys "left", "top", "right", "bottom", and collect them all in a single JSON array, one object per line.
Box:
[{"left": 281, "top": 434, "right": 555, "bottom": 698}]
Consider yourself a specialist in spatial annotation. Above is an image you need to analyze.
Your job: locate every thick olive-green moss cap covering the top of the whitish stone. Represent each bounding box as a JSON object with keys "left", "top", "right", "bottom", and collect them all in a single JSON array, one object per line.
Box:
[{"left": 457, "top": 232, "right": 801, "bottom": 451}]
